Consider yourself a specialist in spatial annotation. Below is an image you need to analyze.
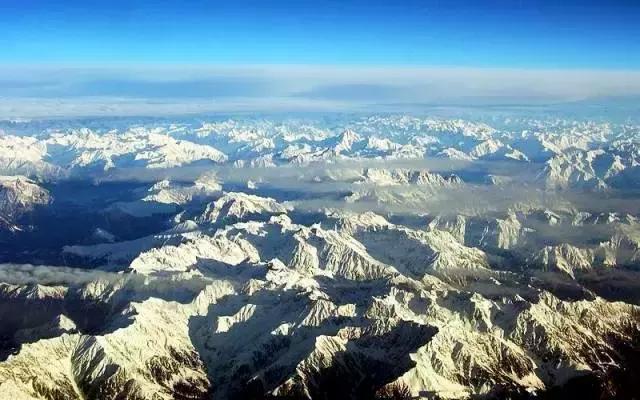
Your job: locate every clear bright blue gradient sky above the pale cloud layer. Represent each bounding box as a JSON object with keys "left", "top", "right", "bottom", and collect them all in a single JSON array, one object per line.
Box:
[{"left": 0, "top": 0, "right": 640, "bottom": 70}]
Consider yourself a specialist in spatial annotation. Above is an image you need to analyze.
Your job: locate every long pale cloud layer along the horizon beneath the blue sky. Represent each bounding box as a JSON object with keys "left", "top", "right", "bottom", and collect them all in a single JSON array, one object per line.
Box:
[{"left": 0, "top": 65, "right": 640, "bottom": 117}]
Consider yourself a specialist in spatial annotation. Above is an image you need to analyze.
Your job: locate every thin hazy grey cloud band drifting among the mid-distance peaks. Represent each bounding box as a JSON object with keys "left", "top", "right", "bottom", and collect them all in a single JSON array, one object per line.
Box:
[{"left": 94, "top": 158, "right": 562, "bottom": 215}]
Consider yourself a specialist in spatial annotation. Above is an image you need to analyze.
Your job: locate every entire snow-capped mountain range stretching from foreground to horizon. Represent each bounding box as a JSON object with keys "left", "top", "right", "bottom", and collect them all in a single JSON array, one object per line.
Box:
[{"left": 0, "top": 115, "right": 640, "bottom": 400}]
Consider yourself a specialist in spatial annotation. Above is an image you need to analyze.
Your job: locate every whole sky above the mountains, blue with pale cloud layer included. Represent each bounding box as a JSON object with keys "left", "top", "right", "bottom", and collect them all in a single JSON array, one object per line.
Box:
[{"left": 0, "top": 0, "right": 640, "bottom": 113}]
